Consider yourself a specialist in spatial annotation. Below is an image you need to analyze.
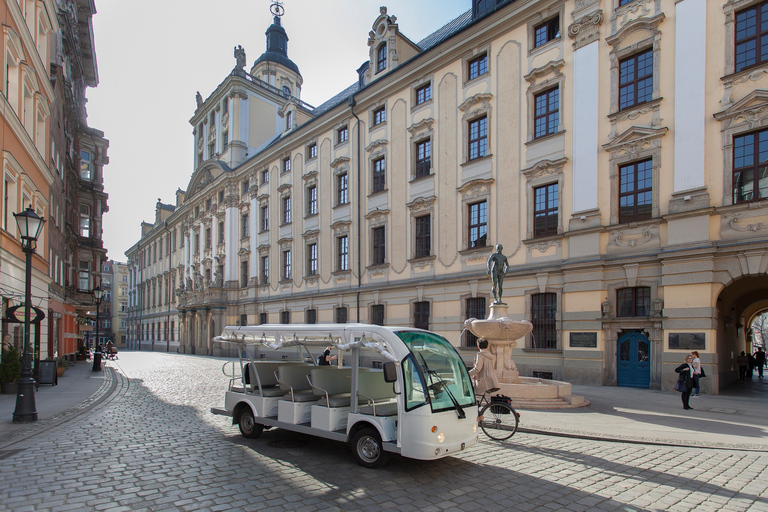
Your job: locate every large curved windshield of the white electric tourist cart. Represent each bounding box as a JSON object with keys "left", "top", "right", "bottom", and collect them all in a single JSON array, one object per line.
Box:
[{"left": 396, "top": 331, "right": 475, "bottom": 412}]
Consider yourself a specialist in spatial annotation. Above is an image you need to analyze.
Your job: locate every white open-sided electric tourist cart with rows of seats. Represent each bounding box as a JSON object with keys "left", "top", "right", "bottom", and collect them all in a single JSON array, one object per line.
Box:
[{"left": 211, "top": 324, "right": 478, "bottom": 467}]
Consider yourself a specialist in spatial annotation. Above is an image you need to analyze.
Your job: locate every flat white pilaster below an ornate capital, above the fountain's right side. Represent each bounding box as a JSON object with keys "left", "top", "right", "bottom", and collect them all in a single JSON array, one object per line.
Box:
[{"left": 572, "top": 41, "right": 600, "bottom": 213}]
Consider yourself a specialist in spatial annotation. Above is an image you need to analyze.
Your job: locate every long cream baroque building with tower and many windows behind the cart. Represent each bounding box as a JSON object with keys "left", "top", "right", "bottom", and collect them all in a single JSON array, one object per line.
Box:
[{"left": 126, "top": 0, "right": 768, "bottom": 393}]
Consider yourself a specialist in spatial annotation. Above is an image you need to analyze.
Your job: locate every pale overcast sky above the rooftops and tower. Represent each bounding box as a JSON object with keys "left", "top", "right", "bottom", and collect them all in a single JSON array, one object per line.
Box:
[{"left": 87, "top": 0, "right": 472, "bottom": 261}]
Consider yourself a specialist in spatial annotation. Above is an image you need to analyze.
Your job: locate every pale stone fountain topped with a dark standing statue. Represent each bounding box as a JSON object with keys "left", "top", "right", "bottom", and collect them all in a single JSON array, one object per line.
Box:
[{"left": 464, "top": 244, "right": 589, "bottom": 409}]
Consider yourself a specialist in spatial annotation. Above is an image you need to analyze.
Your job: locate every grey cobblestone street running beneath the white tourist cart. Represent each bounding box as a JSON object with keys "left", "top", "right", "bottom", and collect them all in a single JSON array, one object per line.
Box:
[{"left": 0, "top": 352, "right": 768, "bottom": 512}]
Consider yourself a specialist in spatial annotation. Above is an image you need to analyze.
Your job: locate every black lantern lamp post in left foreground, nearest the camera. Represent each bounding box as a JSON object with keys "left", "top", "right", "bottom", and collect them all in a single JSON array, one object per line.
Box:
[{"left": 13, "top": 205, "right": 45, "bottom": 423}]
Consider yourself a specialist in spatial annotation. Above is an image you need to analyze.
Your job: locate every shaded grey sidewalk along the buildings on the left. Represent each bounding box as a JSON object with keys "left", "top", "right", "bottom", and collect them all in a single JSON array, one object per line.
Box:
[{"left": 0, "top": 361, "right": 107, "bottom": 437}]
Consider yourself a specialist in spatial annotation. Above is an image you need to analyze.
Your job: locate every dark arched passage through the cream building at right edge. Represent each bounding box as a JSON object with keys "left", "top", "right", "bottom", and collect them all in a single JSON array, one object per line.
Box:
[{"left": 715, "top": 275, "right": 768, "bottom": 389}]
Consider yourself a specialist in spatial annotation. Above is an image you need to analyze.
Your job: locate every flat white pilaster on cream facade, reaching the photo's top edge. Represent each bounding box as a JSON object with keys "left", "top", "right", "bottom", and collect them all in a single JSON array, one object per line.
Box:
[{"left": 674, "top": 0, "right": 707, "bottom": 192}]
